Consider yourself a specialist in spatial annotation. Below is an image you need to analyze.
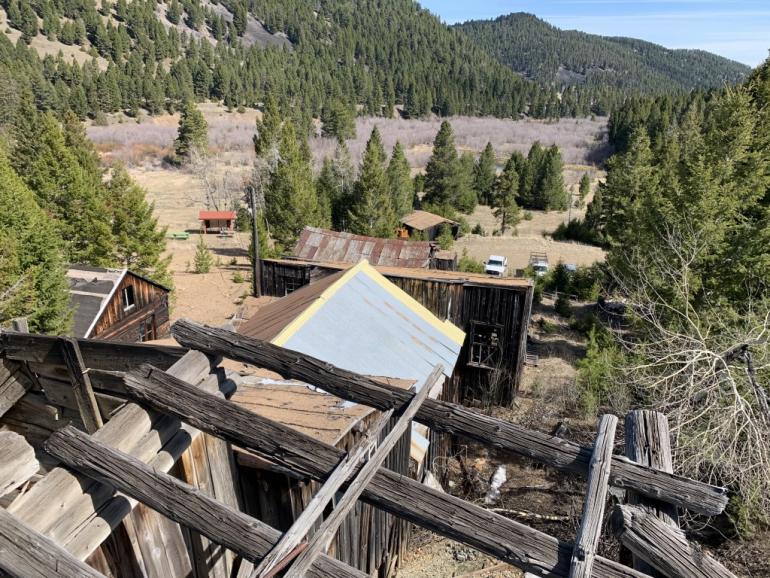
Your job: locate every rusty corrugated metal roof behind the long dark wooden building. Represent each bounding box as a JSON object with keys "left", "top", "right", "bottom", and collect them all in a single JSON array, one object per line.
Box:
[{"left": 293, "top": 227, "right": 433, "bottom": 269}]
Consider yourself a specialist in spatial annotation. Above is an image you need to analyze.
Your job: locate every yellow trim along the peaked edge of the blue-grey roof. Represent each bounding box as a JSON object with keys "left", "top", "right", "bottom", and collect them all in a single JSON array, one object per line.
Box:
[{"left": 272, "top": 259, "right": 465, "bottom": 346}]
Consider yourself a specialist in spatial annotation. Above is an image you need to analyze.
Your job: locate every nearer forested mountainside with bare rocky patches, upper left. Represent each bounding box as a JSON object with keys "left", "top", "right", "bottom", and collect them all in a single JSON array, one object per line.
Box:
[{"left": 0, "top": 0, "right": 574, "bottom": 118}]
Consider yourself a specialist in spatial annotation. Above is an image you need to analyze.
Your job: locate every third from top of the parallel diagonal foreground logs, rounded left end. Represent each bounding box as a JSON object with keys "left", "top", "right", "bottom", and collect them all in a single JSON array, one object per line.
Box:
[{"left": 46, "top": 426, "right": 363, "bottom": 577}]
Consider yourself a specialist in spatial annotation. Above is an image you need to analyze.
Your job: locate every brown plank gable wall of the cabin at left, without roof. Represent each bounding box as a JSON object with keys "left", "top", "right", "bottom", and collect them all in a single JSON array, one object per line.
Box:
[{"left": 89, "top": 272, "right": 169, "bottom": 342}]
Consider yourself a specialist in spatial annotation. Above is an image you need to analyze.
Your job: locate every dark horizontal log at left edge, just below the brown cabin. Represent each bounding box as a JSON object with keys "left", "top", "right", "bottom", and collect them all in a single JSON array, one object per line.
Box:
[{"left": 0, "top": 331, "right": 187, "bottom": 371}]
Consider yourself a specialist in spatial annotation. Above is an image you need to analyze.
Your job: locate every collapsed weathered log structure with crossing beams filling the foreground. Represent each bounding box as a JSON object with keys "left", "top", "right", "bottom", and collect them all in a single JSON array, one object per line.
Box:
[{"left": 0, "top": 321, "right": 730, "bottom": 577}]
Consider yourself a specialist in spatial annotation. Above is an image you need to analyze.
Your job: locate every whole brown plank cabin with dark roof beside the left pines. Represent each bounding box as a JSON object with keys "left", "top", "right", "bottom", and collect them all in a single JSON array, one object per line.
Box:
[{"left": 67, "top": 265, "right": 170, "bottom": 343}]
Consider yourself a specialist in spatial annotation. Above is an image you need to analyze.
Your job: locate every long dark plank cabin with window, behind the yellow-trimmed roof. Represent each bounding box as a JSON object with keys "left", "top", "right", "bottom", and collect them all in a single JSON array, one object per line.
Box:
[{"left": 260, "top": 259, "right": 534, "bottom": 406}]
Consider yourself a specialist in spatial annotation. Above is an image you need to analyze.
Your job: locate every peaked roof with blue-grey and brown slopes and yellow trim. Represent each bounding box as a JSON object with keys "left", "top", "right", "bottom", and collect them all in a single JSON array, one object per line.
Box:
[{"left": 239, "top": 261, "right": 465, "bottom": 384}]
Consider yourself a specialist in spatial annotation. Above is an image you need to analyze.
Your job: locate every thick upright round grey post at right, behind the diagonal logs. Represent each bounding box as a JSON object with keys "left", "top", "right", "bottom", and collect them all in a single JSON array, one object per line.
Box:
[{"left": 625, "top": 410, "right": 679, "bottom": 574}]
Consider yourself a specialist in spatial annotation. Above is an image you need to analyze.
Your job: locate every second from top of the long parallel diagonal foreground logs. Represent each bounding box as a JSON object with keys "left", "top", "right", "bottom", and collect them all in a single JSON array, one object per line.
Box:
[{"left": 123, "top": 367, "right": 644, "bottom": 578}]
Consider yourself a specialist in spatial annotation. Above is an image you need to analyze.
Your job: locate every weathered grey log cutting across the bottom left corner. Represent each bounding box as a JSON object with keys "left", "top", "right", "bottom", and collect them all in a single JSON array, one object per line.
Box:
[{"left": 0, "top": 508, "right": 104, "bottom": 578}]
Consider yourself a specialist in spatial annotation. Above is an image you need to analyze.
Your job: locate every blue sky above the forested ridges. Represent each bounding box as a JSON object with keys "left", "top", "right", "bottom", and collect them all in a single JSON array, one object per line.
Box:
[{"left": 418, "top": 0, "right": 770, "bottom": 66}]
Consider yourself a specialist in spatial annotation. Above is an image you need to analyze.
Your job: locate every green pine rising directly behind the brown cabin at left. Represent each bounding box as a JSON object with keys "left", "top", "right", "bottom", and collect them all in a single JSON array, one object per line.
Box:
[{"left": 107, "top": 165, "right": 172, "bottom": 287}]
